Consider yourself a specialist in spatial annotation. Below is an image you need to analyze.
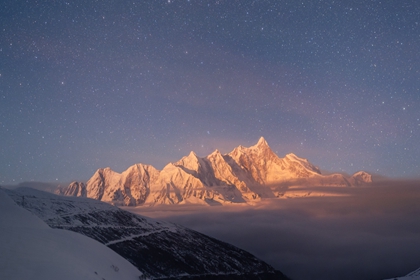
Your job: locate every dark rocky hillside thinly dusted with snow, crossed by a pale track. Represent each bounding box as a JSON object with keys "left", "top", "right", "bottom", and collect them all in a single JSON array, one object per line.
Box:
[{"left": 5, "top": 188, "right": 287, "bottom": 279}]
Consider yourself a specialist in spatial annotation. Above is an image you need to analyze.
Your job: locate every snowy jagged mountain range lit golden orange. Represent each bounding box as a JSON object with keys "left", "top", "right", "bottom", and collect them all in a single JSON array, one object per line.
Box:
[{"left": 56, "top": 137, "right": 372, "bottom": 206}]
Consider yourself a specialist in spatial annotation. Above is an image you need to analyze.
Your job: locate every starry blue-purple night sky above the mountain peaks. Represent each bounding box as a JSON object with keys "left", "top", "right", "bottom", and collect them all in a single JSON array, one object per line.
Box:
[{"left": 0, "top": 0, "right": 420, "bottom": 184}]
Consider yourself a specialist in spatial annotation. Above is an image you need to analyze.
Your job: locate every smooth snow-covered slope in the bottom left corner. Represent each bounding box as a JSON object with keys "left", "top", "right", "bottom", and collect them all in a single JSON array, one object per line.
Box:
[{"left": 0, "top": 188, "right": 142, "bottom": 280}]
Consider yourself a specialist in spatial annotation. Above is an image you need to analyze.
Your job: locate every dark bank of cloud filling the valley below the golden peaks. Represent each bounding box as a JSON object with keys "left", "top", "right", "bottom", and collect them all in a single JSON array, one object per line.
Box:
[{"left": 125, "top": 180, "right": 420, "bottom": 280}]
